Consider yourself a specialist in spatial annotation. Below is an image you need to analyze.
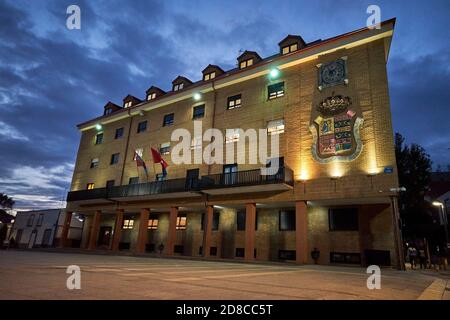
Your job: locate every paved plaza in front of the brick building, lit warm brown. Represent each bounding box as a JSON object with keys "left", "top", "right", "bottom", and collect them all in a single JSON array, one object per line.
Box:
[{"left": 0, "top": 250, "right": 449, "bottom": 300}]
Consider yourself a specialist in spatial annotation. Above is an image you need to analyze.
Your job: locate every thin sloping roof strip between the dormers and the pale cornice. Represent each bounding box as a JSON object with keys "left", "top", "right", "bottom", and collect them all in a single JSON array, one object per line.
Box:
[{"left": 77, "top": 18, "right": 396, "bottom": 128}]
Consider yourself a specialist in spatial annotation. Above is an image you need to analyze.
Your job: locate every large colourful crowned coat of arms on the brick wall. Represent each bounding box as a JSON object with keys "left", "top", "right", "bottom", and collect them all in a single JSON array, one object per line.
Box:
[{"left": 310, "top": 93, "right": 363, "bottom": 163}]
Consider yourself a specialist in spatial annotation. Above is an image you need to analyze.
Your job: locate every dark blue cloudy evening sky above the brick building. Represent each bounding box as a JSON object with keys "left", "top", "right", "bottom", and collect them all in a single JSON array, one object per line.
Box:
[{"left": 0, "top": 0, "right": 450, "bottom": 210}]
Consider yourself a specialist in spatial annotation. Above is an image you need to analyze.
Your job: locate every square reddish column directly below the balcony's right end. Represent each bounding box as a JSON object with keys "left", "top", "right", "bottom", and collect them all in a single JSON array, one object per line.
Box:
[{"left": 295, "top": 201, "right": 309, "bottom": 263}]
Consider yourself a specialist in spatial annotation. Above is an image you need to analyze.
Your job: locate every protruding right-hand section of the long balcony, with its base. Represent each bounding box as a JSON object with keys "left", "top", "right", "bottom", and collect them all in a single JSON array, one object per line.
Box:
[{"left": 200, "top": 167, "right": 294, "bottom": 195}]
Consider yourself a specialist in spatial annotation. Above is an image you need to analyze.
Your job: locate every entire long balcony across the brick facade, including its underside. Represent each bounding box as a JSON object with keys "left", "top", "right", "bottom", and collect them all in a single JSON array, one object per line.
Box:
[{"left": 67, "top": 167, "right": 294, "bottom": 204}]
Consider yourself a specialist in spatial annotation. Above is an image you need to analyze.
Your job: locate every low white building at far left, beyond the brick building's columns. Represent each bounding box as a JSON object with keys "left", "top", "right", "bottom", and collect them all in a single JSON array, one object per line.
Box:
[{"left": 10, "top": 209, "right": 83, "bottom": 248}]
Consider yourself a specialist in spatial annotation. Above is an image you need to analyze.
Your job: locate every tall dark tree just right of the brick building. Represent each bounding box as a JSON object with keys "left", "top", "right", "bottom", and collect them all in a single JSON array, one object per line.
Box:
[{"left": 395, "top": 133, "right": 433, "bottom": 237}]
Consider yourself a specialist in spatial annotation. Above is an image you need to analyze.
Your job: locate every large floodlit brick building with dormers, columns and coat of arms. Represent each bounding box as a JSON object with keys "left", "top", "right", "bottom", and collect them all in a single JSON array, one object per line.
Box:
[{"left": 62, "top": 20, "right": 402, "bottom": 266}]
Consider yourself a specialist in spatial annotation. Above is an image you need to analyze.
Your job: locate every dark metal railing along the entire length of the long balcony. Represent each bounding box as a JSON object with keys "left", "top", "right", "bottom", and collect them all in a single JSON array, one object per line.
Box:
[{"left": 67, "top": 167, "right": 294, "bottom": 202}]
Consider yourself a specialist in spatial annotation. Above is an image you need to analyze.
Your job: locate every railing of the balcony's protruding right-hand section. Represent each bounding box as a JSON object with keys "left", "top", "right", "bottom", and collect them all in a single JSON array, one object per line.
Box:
[{"left": 200, "top": 167, "right": 294, "bottom": 190}]
